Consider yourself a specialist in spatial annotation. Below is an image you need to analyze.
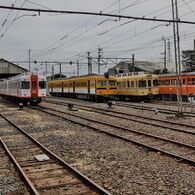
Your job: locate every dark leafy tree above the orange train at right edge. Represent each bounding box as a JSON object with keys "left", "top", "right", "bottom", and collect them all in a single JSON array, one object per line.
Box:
[{"left": 182, "top": 50, "right": 195, "bottom": 71}]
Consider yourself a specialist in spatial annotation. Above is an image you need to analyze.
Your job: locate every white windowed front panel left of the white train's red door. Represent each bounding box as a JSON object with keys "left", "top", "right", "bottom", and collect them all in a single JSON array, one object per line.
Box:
[{"left": 19, "top": 76, "right": 31, "bottom": 98}]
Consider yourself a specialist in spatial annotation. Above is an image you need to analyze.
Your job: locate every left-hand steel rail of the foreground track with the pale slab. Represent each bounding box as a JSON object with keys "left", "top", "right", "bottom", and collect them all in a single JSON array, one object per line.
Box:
[{"left": 0, "top": 138, "right": 39, "bottom": 195}]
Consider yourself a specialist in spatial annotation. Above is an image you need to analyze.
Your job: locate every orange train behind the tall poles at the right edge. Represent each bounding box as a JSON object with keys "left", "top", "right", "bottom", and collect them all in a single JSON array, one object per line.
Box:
[{"left": 159, "top": 72, "right": 195, "bottom": 101}]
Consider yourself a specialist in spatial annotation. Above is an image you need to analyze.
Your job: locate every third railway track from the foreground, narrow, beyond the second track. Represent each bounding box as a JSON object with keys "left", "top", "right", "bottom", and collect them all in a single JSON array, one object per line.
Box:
[{"left": 44, "top": 101, "right": 195, "bottom": 135}]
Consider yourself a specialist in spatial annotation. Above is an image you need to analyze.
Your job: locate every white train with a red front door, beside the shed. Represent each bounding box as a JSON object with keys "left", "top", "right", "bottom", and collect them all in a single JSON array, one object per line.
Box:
[{"left": 0, "top": 72, "right": 46, "bottom": 104}]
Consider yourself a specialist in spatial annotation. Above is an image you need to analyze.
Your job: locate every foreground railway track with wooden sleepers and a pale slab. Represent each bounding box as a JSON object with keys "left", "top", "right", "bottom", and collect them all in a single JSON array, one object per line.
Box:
[{"left": 0, "top": 114, "right": 110, "bottom": 195}]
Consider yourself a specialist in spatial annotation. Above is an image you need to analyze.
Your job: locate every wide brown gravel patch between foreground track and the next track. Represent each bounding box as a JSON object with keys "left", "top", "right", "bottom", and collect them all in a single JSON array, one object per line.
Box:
[{"left": 1, "top": 101, "right": 195, "bottom": 195}]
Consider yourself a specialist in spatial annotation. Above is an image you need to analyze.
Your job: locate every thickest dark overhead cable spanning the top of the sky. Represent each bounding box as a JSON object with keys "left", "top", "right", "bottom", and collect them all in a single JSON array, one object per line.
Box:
[{"left": 0, "top": 6, "right": 195, "bottom": 24}]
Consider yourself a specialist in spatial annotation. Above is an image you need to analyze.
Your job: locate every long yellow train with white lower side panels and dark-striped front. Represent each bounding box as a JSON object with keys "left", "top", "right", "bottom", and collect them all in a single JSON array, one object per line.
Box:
[{"left": 48, "top": 75, "right": 117, "bottom": 101}]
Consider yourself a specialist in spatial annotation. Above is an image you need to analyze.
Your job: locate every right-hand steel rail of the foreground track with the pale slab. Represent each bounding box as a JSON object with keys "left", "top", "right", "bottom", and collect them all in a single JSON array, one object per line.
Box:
[{"left": 0, "top": 113, "right": 111, "bottom": 195}]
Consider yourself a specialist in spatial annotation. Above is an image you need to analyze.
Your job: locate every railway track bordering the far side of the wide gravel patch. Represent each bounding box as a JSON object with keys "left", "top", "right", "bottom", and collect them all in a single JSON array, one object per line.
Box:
[{"left": 33, "top": 104, "right": 195, "bottom": 165}]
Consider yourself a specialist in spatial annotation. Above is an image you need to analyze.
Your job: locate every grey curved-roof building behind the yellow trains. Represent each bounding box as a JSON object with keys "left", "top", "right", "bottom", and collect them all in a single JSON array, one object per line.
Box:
[{"left": 108, "top": 61, "right": 163, "bottom": 75}]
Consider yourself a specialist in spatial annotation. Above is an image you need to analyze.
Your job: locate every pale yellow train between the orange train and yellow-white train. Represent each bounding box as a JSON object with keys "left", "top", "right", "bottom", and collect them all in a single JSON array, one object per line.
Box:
[{"left": 116, "top": 72, "right": 158, "bottom": 101}]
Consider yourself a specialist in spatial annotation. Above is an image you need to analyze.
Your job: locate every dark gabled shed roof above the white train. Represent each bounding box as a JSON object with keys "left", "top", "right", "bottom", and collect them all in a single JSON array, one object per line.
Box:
[{"left": 0, "top": 58, "right": 28, "bottom": 79}]
